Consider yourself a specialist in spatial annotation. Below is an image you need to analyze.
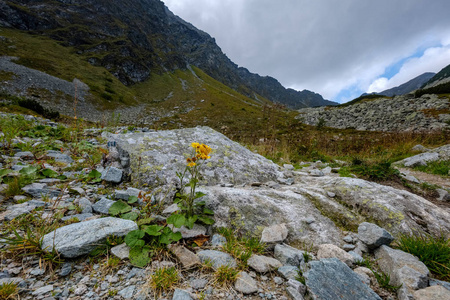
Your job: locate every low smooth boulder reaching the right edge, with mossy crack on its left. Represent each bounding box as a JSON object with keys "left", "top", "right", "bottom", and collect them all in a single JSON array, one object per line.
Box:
[{"left": 296, "top": 177, "right": 450, "bottom": 236}]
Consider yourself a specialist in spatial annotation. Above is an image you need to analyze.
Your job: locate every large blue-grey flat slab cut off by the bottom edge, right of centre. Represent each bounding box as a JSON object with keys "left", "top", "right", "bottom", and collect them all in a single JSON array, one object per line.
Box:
[{"left": 304, "top": 258, "right": 381, "bottom": 300}]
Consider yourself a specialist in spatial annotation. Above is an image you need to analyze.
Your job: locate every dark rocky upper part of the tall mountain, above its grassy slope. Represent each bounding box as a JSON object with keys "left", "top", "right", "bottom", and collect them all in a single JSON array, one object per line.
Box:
[{"left": 0, "top": 0, "right": 336, "bottom": 109}]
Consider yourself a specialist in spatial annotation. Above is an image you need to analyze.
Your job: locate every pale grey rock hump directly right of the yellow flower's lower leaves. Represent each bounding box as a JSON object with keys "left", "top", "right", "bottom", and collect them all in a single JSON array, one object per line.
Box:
[{"left": 200, "top": 186, "right": 341, "bottom": 245}]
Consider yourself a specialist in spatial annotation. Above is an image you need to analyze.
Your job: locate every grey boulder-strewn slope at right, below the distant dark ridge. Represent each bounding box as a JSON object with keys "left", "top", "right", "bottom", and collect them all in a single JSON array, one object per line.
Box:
[{"left": 297, "top": 94, "right": 450, "bottom": 131}]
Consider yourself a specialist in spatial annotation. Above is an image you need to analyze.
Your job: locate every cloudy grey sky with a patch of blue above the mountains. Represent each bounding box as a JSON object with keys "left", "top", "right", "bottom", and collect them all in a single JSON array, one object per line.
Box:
[{"left": 163, "top": 0, "right": 450, "bottom": 102}]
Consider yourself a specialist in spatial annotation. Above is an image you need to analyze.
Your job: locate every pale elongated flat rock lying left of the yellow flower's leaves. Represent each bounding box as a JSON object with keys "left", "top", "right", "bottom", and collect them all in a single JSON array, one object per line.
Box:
[{"left": 42, "top": 217, "right": 138, "bottom": 258}]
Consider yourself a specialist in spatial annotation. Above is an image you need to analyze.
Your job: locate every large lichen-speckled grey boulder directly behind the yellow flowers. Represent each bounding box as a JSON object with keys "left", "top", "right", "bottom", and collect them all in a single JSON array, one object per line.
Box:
[{"left": 106, "top": 127, "right": 281, "bottom": 186}]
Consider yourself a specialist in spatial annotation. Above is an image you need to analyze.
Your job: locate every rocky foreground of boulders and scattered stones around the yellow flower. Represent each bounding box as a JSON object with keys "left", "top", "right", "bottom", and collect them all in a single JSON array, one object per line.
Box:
[{"left": 0, "top": 114, "right": 450, "bottom": 300}]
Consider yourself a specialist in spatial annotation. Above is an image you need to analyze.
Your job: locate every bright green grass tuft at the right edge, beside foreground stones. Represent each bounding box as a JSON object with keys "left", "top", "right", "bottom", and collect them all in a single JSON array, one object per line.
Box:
[{"left": 396, "top": 234, "right": 450, "bottom": 281}]
